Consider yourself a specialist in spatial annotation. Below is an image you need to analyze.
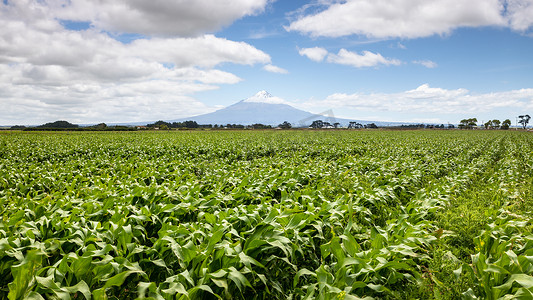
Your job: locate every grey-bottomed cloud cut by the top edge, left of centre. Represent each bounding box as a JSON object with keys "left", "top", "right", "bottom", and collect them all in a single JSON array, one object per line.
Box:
[{"left": 50, "top": 0, "right": 269, "bottom": 36}]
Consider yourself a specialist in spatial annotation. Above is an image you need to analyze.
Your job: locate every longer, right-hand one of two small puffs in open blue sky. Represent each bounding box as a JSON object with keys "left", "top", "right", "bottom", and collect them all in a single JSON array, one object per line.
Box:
[{"left": 327, "top": 49, "right": 402, "bottom": 68}]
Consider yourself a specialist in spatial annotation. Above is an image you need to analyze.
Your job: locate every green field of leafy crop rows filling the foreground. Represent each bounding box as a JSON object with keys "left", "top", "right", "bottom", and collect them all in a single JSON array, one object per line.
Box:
[{"left": 0, "top": 130, "right": 533, "bottom": 299}]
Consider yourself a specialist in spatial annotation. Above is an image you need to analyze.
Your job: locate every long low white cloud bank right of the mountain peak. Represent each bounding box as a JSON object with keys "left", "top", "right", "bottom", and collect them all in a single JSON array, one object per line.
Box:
[{"left": 308, "top": 84, "right": 533, "bottom": 115}]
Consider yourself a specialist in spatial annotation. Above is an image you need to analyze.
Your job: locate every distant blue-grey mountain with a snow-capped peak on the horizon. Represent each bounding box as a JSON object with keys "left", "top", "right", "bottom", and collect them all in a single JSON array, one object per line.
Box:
[{"left": 171, "top": 91, "right": 391, "bottom": 127}]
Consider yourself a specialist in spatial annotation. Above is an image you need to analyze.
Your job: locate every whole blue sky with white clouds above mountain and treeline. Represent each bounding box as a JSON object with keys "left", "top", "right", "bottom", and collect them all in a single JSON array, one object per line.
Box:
[{"left": 0, "top": 0, "right": 533, "bottom": 125}]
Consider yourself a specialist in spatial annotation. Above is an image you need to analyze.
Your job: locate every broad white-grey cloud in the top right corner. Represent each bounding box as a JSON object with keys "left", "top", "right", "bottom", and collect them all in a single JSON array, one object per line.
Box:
[{"left": 286, "top": 0, "right": 533, "bottom": 38}]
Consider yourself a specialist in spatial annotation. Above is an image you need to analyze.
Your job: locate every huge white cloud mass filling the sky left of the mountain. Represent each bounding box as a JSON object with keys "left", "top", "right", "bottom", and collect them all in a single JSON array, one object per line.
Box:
[{"left": 0, "top": 0, "right": 270, "bottom": 124}]
